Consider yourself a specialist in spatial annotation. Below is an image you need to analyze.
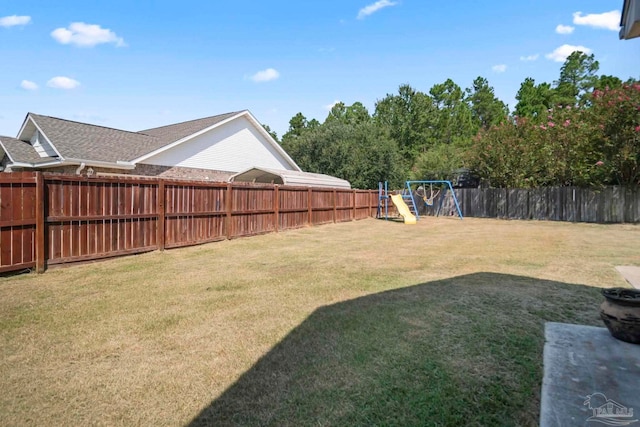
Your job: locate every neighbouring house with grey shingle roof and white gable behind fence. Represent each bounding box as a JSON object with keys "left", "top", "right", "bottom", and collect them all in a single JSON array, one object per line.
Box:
[{"left": 0, "top": 110, "right": 350, "bottom": 186}]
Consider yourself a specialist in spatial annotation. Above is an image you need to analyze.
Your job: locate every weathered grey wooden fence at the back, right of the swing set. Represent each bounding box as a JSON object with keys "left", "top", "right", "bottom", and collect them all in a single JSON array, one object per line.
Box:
[{"left": 425, "top": 187, "right": 640, "bottom": 223}]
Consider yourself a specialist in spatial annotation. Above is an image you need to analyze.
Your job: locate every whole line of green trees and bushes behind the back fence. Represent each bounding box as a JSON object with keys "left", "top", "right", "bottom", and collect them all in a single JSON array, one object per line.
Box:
[{"left": 265, "top": 52, "right": 640, "bottom": 188}]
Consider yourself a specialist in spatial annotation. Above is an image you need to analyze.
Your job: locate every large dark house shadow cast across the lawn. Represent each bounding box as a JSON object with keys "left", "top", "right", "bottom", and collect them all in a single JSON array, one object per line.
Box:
[{"left": 190, "top": 273, "right": 601, "bottom": 426}]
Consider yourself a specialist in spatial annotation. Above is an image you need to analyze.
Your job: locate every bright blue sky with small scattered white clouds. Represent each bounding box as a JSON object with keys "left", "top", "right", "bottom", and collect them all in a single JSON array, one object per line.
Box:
[{"left": 0, "top": 0, "right": 640, "bottom": 136}]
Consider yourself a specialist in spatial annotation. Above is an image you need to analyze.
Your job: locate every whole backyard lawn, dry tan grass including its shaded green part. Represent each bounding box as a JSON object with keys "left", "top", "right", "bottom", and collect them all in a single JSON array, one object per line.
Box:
[{"left": 0, "top": 218, "right": 640, "bottom": 426}]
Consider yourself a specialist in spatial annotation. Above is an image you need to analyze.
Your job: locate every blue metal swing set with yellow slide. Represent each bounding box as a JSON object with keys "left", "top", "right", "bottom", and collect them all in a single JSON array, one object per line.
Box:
[{"left": 376, "top": 180, "right": 462, "bottom": 224}]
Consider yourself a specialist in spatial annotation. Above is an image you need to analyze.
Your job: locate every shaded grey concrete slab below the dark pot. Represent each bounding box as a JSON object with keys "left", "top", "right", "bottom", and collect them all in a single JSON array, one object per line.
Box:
[{"left": 540, "top": 322, "right": 640, "bottom": 427}]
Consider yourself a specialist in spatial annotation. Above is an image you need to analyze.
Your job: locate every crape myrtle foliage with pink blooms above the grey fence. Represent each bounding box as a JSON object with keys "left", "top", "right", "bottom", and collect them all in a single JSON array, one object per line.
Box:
[{"left": 468, "top": 83, "right": 640, "bottom": 187}]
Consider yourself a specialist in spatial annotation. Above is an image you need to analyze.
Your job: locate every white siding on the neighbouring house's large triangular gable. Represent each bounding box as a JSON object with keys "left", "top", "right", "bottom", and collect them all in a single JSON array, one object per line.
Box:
[{"left": 143, "top": 117, "right": 294, "bottom": 172}]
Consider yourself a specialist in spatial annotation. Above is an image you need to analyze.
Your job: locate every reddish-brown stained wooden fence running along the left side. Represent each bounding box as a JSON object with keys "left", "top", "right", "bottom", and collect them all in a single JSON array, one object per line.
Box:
[{"left": 0, "top": 172, "right": 378, "bottom": 272}]
